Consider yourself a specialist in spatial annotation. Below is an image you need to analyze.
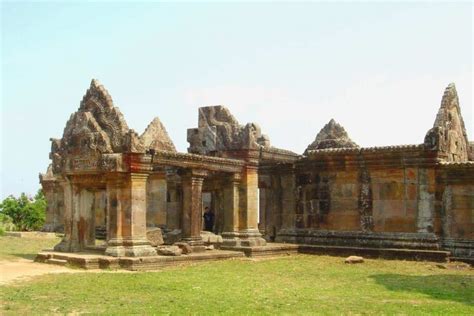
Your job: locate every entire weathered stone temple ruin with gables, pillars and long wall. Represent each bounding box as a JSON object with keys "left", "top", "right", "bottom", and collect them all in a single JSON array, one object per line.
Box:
[{"left": 37, "top": 80, "right": 474, "bottom": 269}]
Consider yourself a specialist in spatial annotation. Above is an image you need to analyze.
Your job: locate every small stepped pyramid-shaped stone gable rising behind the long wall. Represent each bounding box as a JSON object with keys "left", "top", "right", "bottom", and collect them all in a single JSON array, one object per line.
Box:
[{"left": 305, "top": 119, "right": 359, "bottom": 155}]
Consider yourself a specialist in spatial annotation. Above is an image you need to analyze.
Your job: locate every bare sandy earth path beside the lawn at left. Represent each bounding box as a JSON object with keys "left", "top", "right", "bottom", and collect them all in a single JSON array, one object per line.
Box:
[{"left": 0, "top": 259, "right": 84, "bottom": 285}]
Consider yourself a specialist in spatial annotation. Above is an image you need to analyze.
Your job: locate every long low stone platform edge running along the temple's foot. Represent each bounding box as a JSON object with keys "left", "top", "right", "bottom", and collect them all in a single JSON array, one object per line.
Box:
[{"left": 35, "top": 243, "right": 451, "bottom": 271}]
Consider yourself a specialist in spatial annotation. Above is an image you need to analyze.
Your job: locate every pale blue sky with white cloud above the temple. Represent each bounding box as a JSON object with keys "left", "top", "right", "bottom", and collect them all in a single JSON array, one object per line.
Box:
[{"left": 0, "top": 2, "right": 474, "bottom": 198}]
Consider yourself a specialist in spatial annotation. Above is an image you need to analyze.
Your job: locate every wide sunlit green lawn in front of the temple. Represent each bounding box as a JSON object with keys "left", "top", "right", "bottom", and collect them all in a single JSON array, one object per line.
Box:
[{"left": 0, "top": 238, "right": 474, "bottom": 315}]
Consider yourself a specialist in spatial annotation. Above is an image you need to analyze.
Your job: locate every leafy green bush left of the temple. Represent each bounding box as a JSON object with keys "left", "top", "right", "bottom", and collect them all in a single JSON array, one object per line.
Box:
[{"left": 0, "top": 189, "right": 46, "bottom": 231}]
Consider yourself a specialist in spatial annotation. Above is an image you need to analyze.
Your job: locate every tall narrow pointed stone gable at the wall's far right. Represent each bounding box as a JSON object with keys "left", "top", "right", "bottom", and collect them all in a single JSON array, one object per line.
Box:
[{"left": 424, "top": 83, "right": 469, "bottom": 161}]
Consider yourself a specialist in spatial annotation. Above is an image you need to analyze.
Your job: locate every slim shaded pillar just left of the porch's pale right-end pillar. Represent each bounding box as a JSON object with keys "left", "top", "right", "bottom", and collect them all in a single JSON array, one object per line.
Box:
[{"left": 222, "top": 173, "right": 241, "bottom": 247}]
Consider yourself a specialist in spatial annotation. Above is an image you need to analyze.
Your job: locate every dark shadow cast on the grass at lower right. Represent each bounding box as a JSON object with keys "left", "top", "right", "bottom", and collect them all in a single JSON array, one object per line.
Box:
[{"left": 370, "top": 274, "right": 474, "bottom": 306}]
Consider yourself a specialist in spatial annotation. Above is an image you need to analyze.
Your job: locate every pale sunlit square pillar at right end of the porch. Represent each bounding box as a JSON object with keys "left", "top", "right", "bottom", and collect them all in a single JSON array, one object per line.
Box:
[{"left": 239, "top": 165, "right": 266, "bottom": 247}]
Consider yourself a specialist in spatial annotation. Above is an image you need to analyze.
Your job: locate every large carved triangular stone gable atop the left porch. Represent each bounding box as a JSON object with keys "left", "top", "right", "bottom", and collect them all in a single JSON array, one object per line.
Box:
[{"left": 50, "top": 80, "right": 145, "bottom": 174}]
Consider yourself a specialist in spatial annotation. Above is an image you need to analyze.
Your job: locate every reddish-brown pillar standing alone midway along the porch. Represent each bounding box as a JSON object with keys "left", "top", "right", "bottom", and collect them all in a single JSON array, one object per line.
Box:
[{"left": 182, "top": 170, "right": 206, "bottom": 252}]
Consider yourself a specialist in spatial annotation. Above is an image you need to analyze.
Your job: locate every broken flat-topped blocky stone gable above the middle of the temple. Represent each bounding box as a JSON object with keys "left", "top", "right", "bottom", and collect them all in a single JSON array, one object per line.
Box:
[{"left": 188, "top": 105, "right": 270, "bottom": 154}]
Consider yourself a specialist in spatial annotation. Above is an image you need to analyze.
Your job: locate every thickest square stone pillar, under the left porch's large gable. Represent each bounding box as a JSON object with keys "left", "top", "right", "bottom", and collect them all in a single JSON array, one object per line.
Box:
[{"left": 105, "top": 173, "right": 156, "bottom": 257}]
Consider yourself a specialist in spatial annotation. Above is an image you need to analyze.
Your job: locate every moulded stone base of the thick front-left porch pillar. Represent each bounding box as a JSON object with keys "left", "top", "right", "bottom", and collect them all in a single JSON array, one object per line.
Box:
[{"left": 105, "top": 239, "right": 157, "bottom": 257}]
